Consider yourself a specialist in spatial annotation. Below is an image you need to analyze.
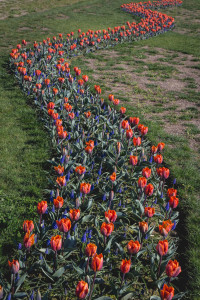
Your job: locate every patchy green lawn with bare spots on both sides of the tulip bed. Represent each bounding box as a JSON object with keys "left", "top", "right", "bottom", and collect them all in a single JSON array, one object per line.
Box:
[{"left": 0, "top": 0, "right": 200, "bottom": 299}]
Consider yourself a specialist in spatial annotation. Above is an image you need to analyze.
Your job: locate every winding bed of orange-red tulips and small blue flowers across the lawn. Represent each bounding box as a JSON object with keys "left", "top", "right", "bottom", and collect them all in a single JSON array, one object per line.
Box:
[{"left": 0, "top": 1, "right": 186, "bottom": 300}]
